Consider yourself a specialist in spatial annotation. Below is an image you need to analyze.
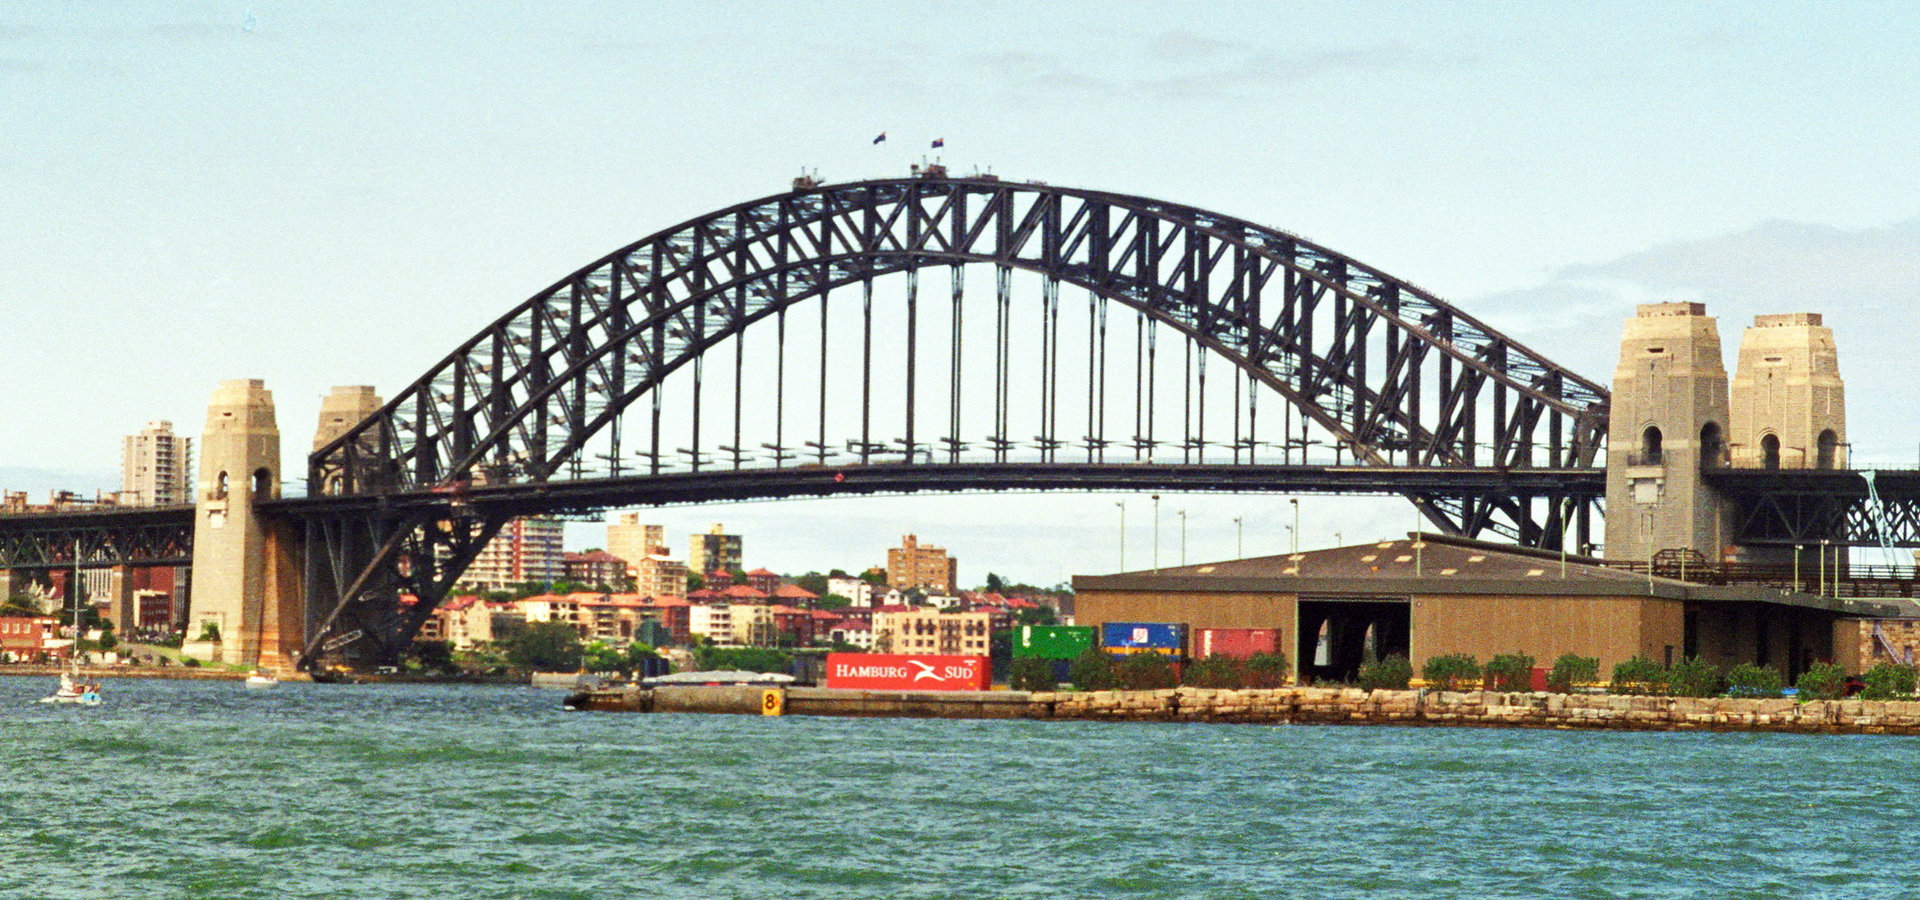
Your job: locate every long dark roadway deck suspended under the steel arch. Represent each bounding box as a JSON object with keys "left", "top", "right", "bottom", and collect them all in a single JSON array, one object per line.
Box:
[{"left": 261, "top": 462, "right": 1607, "bottom": 516}]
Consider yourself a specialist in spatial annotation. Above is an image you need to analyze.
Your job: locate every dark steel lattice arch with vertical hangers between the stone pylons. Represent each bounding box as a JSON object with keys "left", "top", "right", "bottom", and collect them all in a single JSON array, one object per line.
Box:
[{"left": 282, "top": 169, "right": 1607, "bottom": 658}]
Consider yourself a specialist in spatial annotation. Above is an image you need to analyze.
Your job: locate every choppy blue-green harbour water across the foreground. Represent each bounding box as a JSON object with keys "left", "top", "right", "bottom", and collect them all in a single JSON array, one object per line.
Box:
[{"left": 0, "top": 677, "right": 1920, "bottom": 900}]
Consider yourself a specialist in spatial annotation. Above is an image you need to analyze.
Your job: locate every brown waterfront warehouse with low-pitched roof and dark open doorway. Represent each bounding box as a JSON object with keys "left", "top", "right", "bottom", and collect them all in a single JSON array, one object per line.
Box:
[{"left": 1073, "top": 535, "right": 1914, "bottom": 679}]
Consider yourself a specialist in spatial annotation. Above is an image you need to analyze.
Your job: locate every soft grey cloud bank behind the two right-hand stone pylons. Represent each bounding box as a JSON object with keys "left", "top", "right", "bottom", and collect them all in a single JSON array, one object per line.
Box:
[{"left": 1459, "top": 219, "right": 1920, "bottom": 456}]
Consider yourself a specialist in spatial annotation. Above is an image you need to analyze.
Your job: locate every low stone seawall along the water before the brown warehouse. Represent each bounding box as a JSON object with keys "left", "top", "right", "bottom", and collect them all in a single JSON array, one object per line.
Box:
[{"left": 566, "top": 687, "right": 1920, "bottom": 735}]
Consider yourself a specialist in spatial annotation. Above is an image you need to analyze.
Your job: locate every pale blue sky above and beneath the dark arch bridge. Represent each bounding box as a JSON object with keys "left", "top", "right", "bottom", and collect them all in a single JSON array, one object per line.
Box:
[{"left": 0, "top": 0, "right": 1920, "bottom": 583}]
